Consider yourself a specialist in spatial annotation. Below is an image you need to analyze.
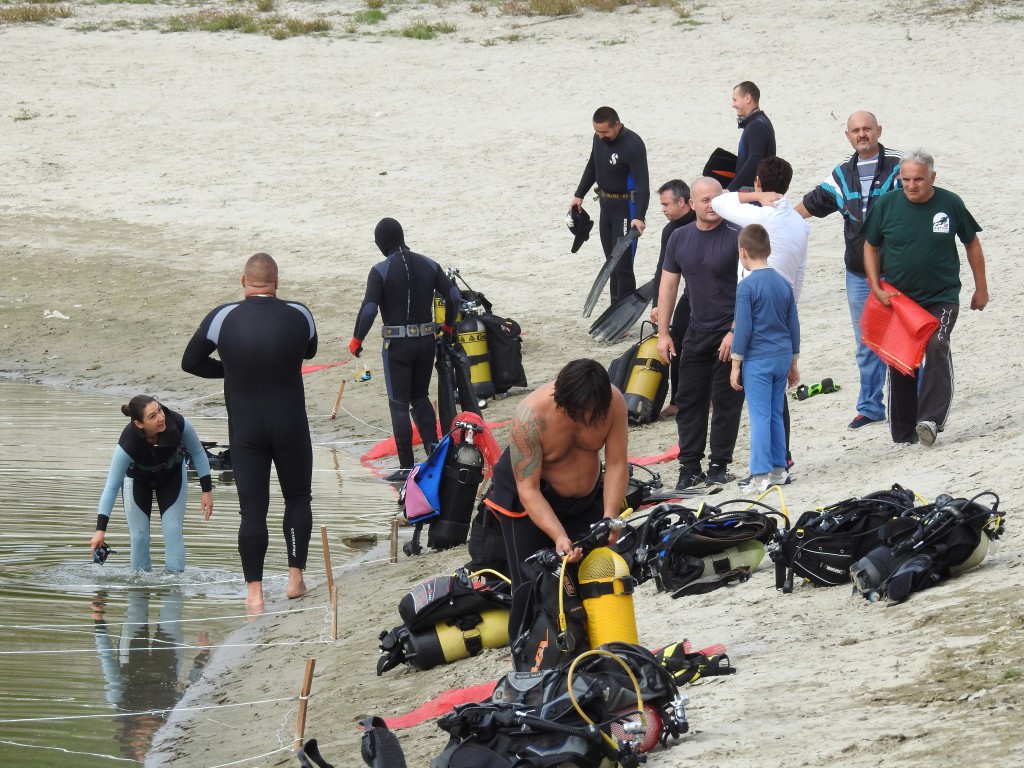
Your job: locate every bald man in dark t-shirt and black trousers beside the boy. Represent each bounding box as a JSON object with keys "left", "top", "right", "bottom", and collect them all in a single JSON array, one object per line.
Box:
[{"left": 657, "top": 176, "right": 743, "bottom": 490}]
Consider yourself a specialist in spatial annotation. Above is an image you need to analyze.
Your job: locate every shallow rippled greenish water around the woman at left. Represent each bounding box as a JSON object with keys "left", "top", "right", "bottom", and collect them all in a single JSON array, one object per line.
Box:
[{"left": 0, "top": 380, "right": 395, "bottom": 767}]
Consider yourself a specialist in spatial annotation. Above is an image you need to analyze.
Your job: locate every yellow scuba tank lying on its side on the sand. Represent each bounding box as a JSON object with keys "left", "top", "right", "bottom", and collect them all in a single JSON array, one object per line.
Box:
[{"left": 404, "top": 608, "right": 509, "bottom": 670}]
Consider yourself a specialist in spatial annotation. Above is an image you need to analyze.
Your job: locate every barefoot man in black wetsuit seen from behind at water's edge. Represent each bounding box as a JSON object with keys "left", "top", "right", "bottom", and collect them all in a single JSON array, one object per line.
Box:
[{"left": 181, "top": 253, "right": 316, "bottom": 612}]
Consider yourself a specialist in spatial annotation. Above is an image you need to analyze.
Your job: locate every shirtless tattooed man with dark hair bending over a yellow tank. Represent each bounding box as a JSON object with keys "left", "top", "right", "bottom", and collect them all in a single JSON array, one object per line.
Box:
[{"left": 484, "top": 359, "right": 629, "bottom": 593}]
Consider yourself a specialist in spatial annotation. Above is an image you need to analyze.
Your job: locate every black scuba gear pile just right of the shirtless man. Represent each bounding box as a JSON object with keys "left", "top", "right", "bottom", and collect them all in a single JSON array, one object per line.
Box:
[{"left": 630, "top": 500, "right": 788, "bottom": 598}]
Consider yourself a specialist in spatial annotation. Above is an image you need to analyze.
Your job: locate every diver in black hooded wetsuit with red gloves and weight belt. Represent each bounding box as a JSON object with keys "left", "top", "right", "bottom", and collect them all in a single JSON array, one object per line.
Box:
[{"left": 348, "top": 218, "right": 461, "bottom": 482}]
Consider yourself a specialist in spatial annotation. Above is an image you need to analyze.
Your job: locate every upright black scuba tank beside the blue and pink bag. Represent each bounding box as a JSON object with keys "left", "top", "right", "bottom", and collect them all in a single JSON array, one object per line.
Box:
[{"left": 427, "top": 421, "right": 485, "bottom": 552}]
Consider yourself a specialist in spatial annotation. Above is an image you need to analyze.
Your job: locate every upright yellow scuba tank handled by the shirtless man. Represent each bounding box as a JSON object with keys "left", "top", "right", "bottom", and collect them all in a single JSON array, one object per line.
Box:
[{"left": 580, "top": 547, "right": 639, "bottom": 648}]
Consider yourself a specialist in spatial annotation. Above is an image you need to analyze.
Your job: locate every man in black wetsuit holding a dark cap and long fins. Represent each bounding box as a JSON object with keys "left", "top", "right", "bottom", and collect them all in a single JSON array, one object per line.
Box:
[{"left": 569, "top": 106, "right": 650, "bottom": 303}]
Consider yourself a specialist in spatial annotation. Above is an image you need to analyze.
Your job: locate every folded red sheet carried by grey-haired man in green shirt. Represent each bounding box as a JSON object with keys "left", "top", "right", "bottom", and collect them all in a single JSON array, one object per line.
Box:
[{"left": 860, "top": 281, "right": 939, "bottom": 376}]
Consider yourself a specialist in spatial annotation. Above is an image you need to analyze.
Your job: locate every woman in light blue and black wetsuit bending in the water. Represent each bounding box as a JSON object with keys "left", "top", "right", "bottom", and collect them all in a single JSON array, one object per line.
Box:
[{"left": 90, "top": 394, "right": 213, "bottom": 572}]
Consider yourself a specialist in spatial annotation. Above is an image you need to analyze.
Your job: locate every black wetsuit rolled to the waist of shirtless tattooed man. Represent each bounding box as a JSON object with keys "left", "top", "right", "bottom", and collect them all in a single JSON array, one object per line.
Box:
[{"left": 483, "top": 449, "right": 604, "bottom": 595}]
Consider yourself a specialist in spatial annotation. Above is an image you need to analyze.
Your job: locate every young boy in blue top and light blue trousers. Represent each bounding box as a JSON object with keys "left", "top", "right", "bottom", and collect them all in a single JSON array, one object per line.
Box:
[{"left": 730, "top": 224, "right": 800, "bottom": 493}]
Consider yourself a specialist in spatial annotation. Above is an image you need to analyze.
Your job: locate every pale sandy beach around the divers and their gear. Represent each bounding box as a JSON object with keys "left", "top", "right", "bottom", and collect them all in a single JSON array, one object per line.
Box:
[{"left": 0, "top": 0, "right": 1024, "bottom": 768}]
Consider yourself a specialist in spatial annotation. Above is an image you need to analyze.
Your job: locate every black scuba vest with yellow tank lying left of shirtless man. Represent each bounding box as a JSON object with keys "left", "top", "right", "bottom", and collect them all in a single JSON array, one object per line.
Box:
[{"left": 377, "top": 568, "right": 512, "bottom": 676}]
